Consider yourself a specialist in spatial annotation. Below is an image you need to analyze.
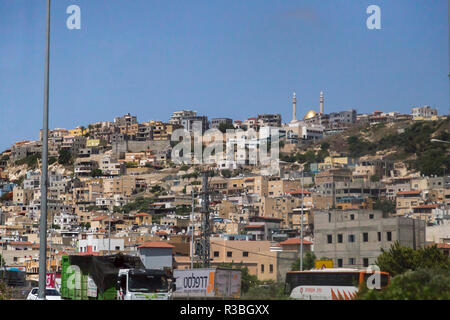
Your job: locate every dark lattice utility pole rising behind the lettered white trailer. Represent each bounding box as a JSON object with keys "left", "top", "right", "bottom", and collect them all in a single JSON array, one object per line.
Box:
[{"left": 200, "top": 170, "right": 211, "bottom": 268}]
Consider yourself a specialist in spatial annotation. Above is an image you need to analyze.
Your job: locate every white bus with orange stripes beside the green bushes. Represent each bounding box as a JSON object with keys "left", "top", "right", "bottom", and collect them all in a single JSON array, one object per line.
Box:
[{"left": 285, "top": 268, "right": 390, "bottom": 300}]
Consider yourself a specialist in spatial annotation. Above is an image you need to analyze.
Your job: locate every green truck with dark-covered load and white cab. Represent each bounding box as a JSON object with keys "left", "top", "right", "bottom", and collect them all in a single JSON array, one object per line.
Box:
[{"left": 60, "top": 254, "right": 172, "bottom": 300}]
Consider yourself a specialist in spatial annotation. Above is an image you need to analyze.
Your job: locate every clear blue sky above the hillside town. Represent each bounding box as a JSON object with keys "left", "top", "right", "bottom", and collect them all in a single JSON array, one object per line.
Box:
[{"left": 0, "top": 0, "right": 449, "bottom": 150}]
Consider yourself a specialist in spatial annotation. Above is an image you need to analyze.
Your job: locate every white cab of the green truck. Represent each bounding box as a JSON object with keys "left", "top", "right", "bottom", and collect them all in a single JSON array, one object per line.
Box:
[{"left": 116, "top": 269, "right": 172, "bottom": 300}]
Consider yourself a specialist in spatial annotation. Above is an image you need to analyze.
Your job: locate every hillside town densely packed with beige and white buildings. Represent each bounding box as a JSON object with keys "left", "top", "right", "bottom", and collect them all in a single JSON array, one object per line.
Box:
[{"left": 0, "top": 92, "right": 450, "bottom": 298}]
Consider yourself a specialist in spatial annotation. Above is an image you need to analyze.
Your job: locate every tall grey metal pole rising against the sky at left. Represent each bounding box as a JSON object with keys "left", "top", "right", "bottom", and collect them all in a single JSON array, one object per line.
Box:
[{"left": 39, "top": 0, "right": 51, "bottom": 300}]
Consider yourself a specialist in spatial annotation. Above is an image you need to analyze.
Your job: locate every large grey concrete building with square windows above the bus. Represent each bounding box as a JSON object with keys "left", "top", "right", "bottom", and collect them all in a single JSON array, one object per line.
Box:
[{"left": 314, "top": 210, "right": 425, "bottom": 268}]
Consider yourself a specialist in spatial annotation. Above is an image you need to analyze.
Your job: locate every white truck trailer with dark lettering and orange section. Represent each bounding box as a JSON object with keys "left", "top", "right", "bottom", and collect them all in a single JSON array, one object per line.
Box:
[{"left": 173, "top": 268, "right": 241, "bottom": 299}]
